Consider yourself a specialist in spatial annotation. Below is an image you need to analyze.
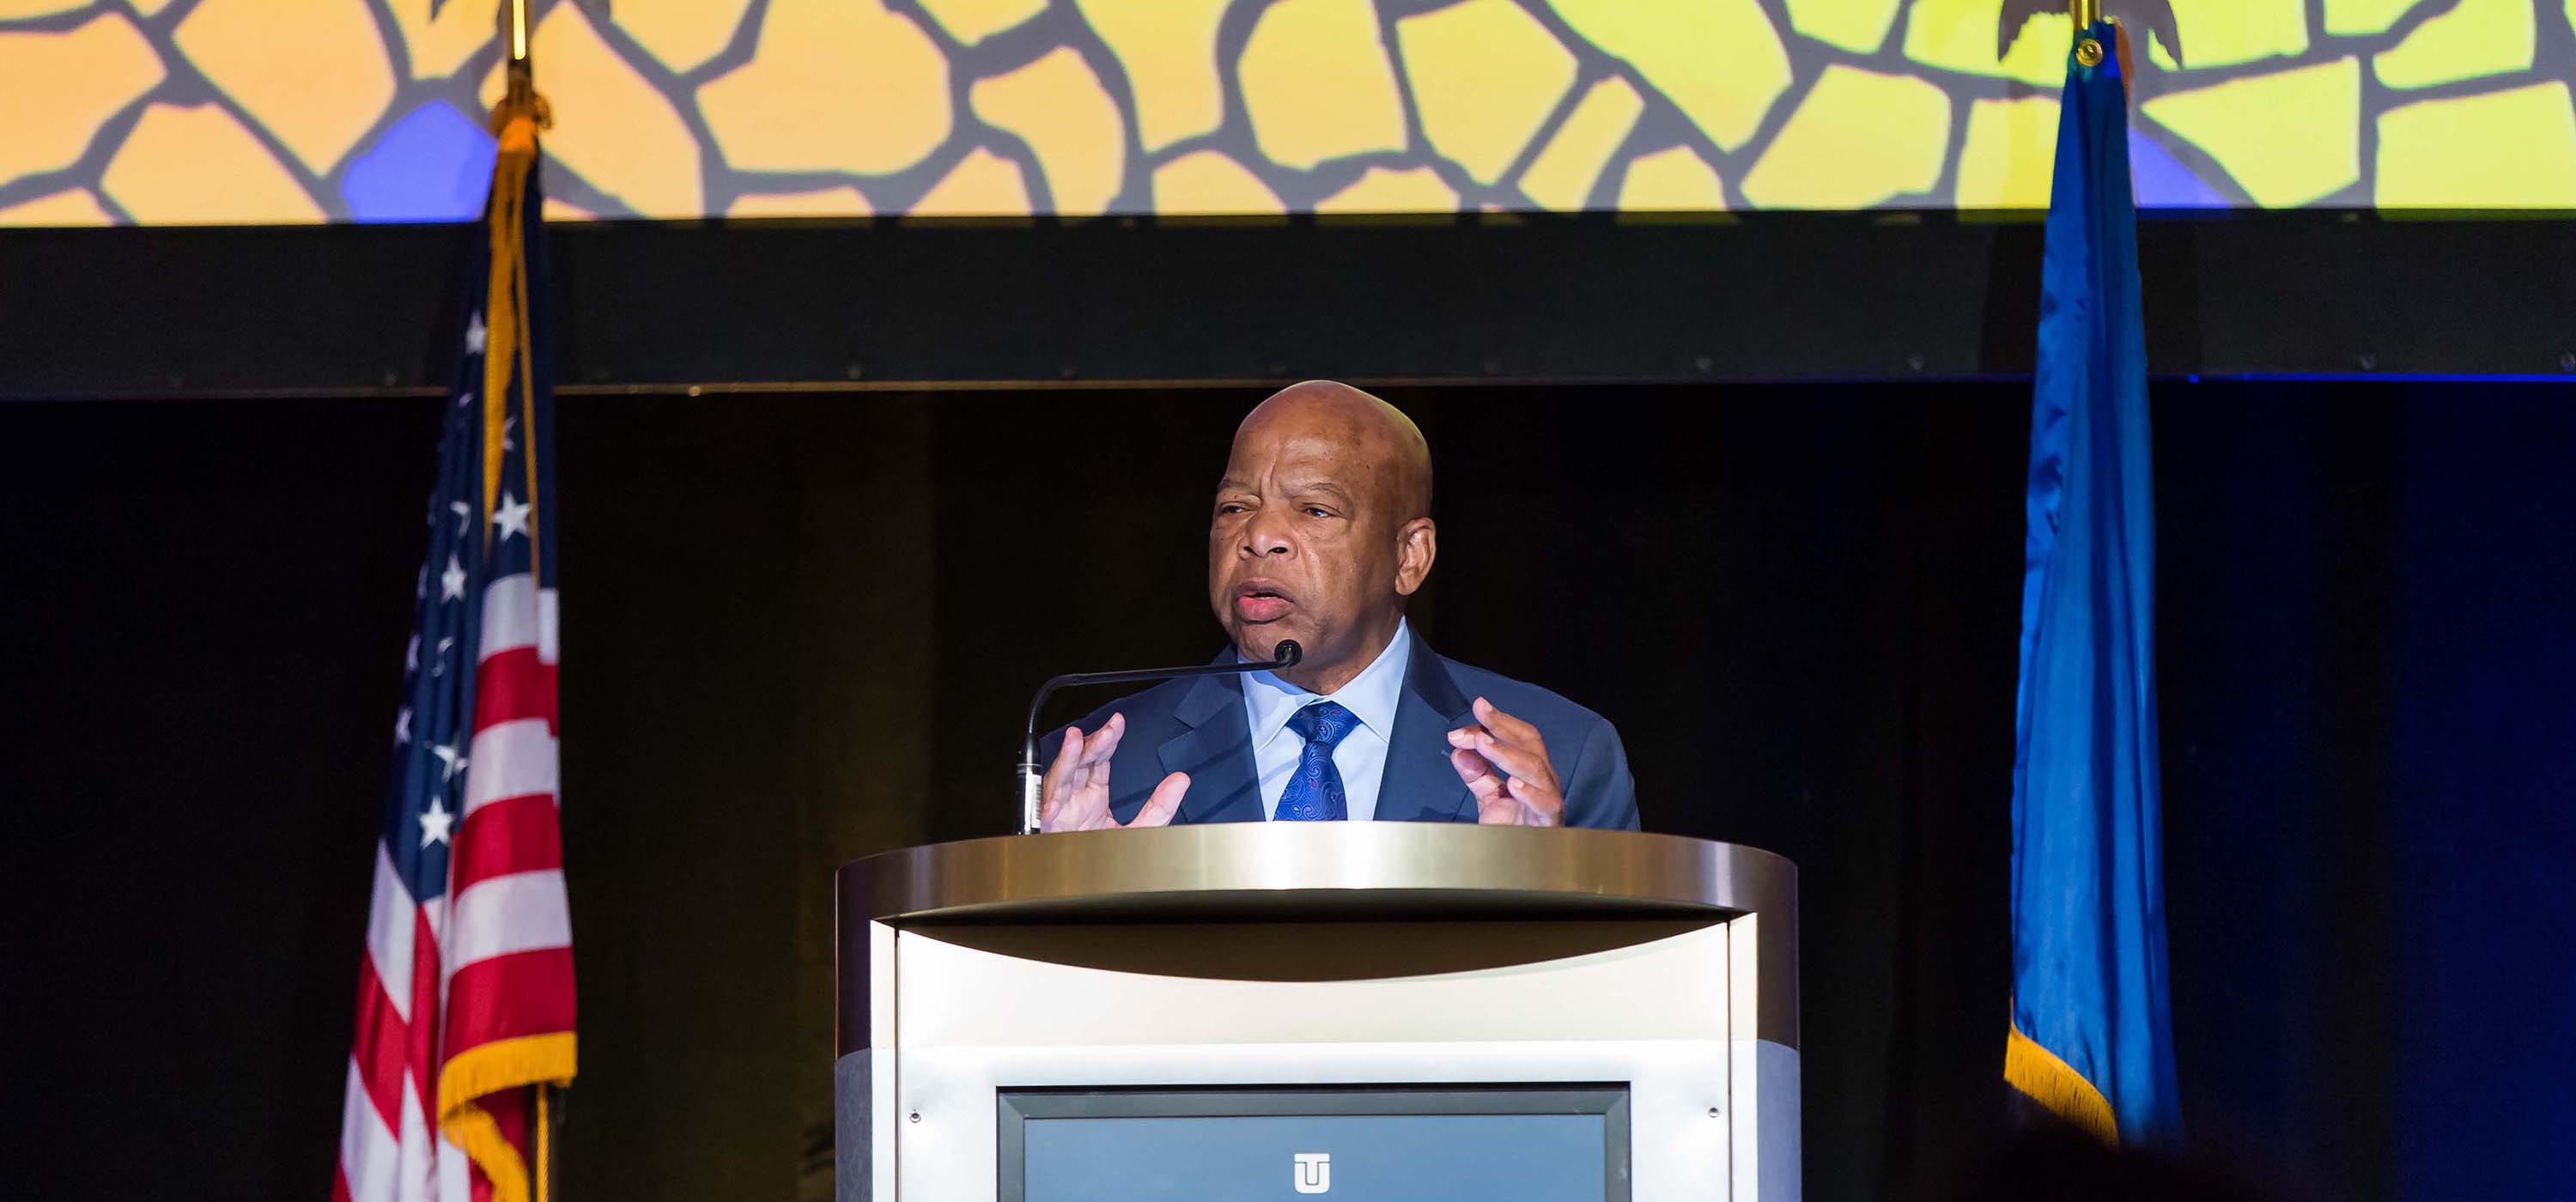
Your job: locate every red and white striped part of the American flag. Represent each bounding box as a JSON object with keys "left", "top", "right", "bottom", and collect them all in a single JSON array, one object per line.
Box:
[{"left": 332, "top": 574, "right": 572, "bottom": 1202}]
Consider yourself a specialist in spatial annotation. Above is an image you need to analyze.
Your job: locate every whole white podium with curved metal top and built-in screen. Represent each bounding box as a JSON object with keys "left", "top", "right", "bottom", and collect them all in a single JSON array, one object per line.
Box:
[{"left": 835, "top": 821, "right": 1798, "bottom": 1202}]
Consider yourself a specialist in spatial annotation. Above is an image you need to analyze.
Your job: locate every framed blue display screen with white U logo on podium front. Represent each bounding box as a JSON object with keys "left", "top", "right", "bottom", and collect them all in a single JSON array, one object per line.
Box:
[{"left": 997, "top": 1084, "right": 1628, "bottom": 1202}]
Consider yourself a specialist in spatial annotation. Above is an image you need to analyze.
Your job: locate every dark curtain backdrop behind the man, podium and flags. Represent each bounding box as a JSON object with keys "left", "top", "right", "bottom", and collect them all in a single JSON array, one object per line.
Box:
[{"left": 0, "top": 384, "right": 2576, "bottom": 1202}]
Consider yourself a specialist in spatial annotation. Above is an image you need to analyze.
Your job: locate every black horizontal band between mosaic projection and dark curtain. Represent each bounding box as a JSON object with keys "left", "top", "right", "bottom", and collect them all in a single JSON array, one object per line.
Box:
[{"left": 15, "top": 211, "right": 2576, "bottom": 399}]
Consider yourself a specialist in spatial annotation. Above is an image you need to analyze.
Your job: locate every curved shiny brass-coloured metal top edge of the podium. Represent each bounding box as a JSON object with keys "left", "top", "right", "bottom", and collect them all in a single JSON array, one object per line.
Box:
[{"left": 840, "top": 821, "right": 1798, "bottom": 926}]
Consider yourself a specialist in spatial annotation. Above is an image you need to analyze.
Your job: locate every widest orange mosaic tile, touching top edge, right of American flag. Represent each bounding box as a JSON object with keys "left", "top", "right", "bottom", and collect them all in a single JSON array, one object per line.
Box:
[{"left": 698, "top": 0, "right": 948, "bottom": 180}]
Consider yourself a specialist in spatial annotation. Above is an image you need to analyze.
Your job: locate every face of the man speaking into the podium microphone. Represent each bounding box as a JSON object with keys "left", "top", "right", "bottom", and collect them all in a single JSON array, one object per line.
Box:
[{"left": 1208, "top": 410, "right": 1430, "bottom": 687}]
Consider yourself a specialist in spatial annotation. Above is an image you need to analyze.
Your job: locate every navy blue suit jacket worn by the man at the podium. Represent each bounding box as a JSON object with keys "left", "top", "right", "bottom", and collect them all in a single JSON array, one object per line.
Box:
[{"left": 1038, "top": 635, "right": 1638, "bottom": 831}]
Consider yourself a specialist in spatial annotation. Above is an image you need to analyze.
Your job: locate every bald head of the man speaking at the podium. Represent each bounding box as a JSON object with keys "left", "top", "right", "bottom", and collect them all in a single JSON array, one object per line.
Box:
[{"left": 1208, "top": 381, "right": 1437, "bottom": 692}]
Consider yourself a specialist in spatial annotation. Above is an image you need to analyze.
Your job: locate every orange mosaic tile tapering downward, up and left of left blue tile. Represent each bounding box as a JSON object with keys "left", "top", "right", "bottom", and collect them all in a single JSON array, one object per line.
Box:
[{"left": 178, "top": 0, "right": 394, "bottom": 175}]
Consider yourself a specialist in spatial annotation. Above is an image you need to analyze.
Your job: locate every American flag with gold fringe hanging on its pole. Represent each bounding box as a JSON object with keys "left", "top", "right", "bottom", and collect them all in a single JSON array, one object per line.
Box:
[{"left": 332, "top": 84, "right": 574, "bottom": 1202}]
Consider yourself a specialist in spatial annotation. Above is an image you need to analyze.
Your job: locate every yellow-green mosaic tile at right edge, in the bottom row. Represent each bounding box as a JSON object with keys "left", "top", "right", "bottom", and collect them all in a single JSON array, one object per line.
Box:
[{"left": 2378, "top": 82, "right": 2576, "bottom": 209}]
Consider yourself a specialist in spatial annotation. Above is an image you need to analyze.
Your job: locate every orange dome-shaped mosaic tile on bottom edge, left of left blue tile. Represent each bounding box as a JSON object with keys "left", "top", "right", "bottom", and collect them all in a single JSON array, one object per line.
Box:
[{"left": 100, "top": 103, "right": 322, "bottom": 224}]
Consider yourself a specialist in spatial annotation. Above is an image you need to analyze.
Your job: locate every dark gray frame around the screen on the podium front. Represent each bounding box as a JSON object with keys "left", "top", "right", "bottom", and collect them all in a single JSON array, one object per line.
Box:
[{"left": 994, "top": 1081, "right": 1631, "bottom": 1202}]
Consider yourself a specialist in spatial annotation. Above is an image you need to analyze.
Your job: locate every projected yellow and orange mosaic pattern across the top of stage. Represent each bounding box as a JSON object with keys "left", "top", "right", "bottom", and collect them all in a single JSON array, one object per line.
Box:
[{"left": 0, "top": 0, "right": 2576, "bottom": 224}]
